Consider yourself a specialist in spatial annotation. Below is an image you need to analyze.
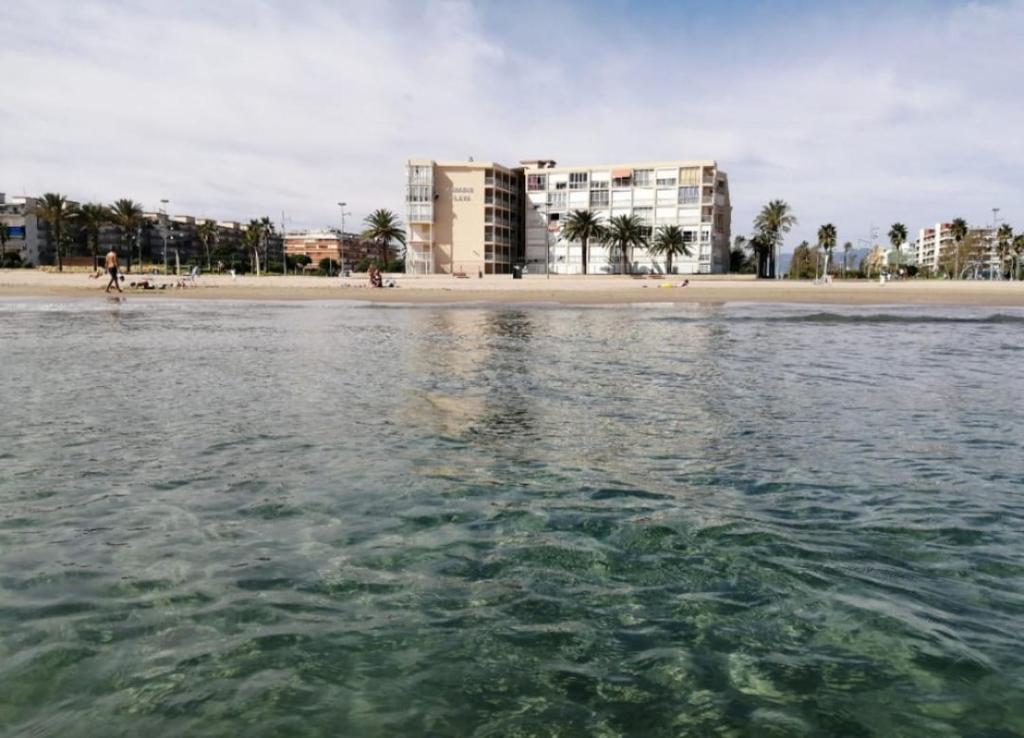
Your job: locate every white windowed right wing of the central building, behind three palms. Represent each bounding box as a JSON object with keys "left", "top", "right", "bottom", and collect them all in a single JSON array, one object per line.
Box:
[{"left": 522, "top": 161, "right": 732, "bottom": 274}]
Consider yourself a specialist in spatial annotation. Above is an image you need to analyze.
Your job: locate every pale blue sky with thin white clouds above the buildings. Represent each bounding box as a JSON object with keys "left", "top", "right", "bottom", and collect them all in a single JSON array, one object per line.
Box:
[{"left": 0, "top": 0, "right": 1024, "bottom": 250}]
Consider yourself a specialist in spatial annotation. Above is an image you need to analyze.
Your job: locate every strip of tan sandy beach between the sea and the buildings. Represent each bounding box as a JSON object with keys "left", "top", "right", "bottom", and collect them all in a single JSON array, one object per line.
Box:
[{"left": 0, "top": 269, "right": 1024, "bottom": 307}]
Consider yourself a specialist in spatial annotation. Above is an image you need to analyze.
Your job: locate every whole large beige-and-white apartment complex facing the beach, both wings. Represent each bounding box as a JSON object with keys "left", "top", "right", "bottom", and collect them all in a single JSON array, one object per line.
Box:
[{"left": 406, "top": 159, "right": 732, "bottom": 274}]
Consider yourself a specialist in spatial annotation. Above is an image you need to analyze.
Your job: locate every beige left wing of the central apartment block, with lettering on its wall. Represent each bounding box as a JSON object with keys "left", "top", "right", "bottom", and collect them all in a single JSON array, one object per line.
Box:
[{"left": 406, "top": 159, "right": 522, "bottom": 276}]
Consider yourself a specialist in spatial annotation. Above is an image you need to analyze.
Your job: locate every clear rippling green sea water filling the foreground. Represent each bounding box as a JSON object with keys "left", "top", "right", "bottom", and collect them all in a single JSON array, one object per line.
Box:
[{"left": 0, "top": 300, "right": 1024, "bottom": 737}]
